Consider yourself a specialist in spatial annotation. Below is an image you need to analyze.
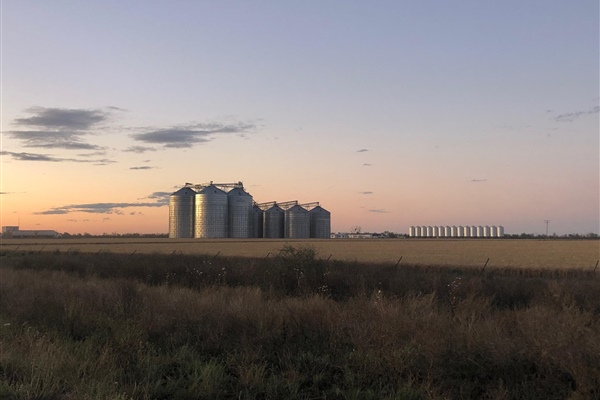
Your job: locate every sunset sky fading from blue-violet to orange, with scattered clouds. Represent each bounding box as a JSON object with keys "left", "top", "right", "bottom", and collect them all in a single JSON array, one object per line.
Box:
[{"left": 0, "top": 0, "right": 600, "bottom": 234}]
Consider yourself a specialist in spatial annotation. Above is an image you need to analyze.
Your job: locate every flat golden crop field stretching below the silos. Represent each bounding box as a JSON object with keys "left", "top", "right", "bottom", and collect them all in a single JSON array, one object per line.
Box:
[{"left": 0, "top": 238, "right": 600, "bottom": 269}]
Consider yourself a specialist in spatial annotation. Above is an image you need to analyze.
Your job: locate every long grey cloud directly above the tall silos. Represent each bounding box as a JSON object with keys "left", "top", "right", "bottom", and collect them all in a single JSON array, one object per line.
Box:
[{"left": 131, "top": 122, "right": 256, "bottom": 148}]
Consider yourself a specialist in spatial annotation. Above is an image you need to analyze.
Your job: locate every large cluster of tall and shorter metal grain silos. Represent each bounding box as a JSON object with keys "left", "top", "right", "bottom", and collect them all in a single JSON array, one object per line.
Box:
[{"left": 169, "top": 181, "right": 331, "bottom": 239}]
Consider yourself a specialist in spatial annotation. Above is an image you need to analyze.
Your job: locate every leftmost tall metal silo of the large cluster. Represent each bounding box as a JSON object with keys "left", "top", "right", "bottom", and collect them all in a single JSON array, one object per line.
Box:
[{"left": 169, "top": 187, "right": 196, "bottom": 238}]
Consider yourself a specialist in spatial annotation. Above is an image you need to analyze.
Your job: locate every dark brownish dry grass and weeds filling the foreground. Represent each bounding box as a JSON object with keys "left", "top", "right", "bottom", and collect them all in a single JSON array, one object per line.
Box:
[{"left": 0, "top": 248, "right": 600, "bottom": 399}]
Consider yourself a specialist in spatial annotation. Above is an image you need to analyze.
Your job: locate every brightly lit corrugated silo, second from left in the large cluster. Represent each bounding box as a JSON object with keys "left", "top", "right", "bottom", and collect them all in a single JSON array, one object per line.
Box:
[{"left": 194, "top": 185, "right": 228, "bottom": 238}]
